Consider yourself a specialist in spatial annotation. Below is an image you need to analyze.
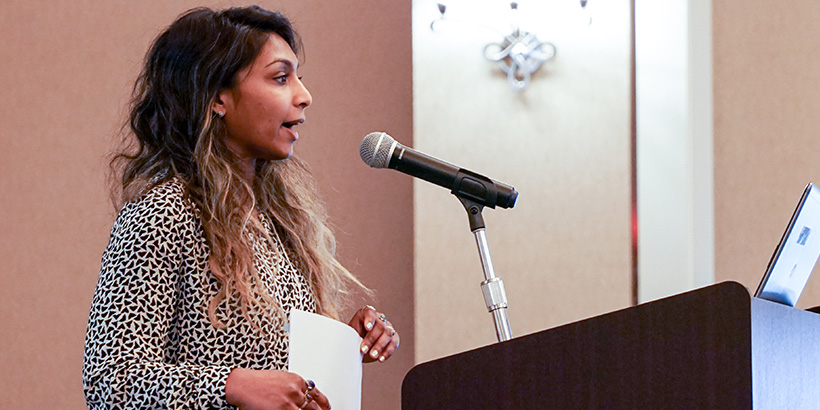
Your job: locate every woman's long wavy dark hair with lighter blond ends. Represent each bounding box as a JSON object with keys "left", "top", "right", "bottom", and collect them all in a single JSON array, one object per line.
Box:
[{"left": 111, "top": 6, "right": 367, "bottom": 328}]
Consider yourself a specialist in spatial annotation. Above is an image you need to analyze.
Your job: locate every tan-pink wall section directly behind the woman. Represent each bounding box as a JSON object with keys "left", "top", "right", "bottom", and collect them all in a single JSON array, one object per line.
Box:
[{"left": 0, "top": 0, "right": 414, "bottom": 409}]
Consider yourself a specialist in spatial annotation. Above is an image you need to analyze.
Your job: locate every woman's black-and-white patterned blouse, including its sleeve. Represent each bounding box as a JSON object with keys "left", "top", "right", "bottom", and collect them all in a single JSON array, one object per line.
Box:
[{"left": 83, "top": 179, "right": 316, "bottom": 409}]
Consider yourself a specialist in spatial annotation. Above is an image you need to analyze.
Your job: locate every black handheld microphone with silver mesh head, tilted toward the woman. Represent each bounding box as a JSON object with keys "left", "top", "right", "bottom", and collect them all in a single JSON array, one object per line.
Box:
[{"left": 359, "top": 132, "right": 518, "bottom": 208}]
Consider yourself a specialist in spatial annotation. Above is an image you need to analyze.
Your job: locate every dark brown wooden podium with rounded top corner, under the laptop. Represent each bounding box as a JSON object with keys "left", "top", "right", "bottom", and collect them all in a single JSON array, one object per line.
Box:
[{"left": 402, "top": 282, "right": 820, "bottom": 410}]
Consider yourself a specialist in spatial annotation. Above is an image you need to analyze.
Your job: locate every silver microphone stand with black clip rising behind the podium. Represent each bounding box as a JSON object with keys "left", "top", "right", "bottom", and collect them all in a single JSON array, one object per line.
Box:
[{"left": 456, "top": 195, "right": 512, "bottom": 342}]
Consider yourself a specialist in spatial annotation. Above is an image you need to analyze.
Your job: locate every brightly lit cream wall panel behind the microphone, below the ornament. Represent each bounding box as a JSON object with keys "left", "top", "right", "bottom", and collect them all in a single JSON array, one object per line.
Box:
[{"left": 410, "top": 0, "right": 632, "bottom": 361}]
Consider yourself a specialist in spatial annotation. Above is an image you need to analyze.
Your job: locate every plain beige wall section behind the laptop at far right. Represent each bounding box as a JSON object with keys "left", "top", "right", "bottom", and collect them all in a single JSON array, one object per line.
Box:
[{"left": 713, "top": 0, "right": 820, "bottom": 307}]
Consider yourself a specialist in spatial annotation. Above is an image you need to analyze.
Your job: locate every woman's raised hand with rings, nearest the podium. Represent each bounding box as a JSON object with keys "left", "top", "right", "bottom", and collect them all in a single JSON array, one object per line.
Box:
[{"left": 348, "top": 305, "right": 399, "bottom": 363}]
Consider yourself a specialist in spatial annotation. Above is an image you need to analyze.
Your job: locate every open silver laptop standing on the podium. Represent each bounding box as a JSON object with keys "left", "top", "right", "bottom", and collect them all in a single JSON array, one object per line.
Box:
[{"left": 755, "top": 183, "right": 820, "bottom": 307}]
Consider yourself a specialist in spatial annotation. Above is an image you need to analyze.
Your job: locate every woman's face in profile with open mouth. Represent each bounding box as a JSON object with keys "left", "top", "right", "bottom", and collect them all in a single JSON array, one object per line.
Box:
[{"left": 214, "top": 34, "right": 311, "bottom": 160}]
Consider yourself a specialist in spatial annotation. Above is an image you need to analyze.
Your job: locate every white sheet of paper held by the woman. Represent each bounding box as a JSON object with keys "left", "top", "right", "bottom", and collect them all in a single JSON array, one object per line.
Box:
[{"left": 288, "top": 309, "right": 362, "bottom": 410}]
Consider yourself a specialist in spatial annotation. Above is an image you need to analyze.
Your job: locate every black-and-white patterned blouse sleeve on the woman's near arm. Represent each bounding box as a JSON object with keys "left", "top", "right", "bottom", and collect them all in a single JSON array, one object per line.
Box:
[{"left": 83, "top": 190, "right": 233, "bottom": 409}]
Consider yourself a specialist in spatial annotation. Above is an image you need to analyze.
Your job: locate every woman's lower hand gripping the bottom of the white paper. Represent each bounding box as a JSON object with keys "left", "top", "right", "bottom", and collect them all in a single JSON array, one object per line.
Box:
[{"left": 225, "top": 368, "right": 330, "bottom": 410}]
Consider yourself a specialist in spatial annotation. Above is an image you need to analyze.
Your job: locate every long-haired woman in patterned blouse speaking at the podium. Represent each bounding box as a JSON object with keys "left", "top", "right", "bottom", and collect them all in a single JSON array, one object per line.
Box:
[{"left": 83, "top": 6, "right": 399, "bottom": 410}]
